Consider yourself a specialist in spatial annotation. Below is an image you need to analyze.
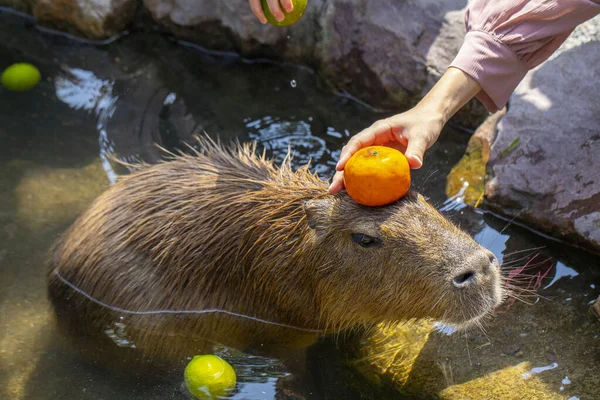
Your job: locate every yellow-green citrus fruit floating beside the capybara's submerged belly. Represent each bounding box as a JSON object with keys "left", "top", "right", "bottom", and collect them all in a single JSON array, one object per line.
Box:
[{"left": 183, "top": 355, "right": 237, "bottom": 400}]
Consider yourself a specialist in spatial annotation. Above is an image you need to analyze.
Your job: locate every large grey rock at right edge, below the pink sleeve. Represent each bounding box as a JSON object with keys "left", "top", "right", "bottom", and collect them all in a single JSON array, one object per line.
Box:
[{"left": 486, "top": 17, "right": 600, "bottom": 250}]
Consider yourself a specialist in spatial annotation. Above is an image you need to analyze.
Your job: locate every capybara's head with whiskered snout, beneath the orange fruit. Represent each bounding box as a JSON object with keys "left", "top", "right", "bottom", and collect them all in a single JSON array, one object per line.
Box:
[{"left": 305, "top": 192, "right": 504, "bottom": 328}]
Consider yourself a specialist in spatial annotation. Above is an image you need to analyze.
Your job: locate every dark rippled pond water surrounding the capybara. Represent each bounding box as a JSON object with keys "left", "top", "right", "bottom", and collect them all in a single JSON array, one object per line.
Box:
[{"left": 0, "top": 11, "right": 600, "bottom": 400}]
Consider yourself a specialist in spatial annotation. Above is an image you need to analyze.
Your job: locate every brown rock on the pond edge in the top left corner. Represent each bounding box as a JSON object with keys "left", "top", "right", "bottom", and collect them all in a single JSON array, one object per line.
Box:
[{"left": 0, "top": 0, "right": 137, "bottom": 39}]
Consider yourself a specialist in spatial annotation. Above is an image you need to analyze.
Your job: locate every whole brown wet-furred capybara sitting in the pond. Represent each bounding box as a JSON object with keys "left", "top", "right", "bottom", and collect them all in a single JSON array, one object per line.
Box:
[{"left": 49, "top": 137, "right": 504, "bottom": 370}]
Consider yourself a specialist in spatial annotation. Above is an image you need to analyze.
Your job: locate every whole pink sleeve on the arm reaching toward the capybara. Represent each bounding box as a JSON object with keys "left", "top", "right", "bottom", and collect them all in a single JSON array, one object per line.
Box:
[{"left": 450, "top": 0, "right": 600, "bottom": 112}]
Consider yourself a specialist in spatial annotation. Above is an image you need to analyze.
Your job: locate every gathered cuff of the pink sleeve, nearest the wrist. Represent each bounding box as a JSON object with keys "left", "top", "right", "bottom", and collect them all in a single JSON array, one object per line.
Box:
[{"left": 450, "top": 31, "right": 528, "bottom": 112}]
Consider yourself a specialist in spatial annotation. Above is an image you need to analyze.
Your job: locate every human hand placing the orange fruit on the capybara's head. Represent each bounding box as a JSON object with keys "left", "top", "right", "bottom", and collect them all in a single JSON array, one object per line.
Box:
[{"left": 329, "top": 106, "right": 444, "bottom": 194}]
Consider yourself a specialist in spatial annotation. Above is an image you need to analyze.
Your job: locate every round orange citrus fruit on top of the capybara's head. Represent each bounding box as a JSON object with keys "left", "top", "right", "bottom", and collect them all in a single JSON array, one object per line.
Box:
[{"left": 344, "top": 146, "right": 410, "bottom": 207}]
